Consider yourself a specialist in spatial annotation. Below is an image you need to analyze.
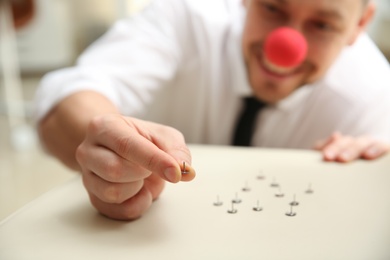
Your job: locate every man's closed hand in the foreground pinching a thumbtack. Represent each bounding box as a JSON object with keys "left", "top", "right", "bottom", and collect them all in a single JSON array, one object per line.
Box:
[{"left": 76, "top": 114, "right": 195, "bottom": 220}]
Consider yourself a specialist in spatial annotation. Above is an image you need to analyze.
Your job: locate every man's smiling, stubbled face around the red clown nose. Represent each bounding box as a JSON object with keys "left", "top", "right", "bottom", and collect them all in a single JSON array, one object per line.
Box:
[{"left": 242, "top": 0, "right": 373, "bottom": 103}]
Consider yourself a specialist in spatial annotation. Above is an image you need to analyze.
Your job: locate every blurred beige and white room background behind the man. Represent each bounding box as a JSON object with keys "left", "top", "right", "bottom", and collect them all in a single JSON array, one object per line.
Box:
[{"left": 0, "top": 0, "right": 390, "bottom": 221}]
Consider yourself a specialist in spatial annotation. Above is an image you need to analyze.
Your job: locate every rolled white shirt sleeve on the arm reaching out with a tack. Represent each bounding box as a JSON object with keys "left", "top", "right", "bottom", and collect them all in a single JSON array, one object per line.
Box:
[{"left": 34, "top": 0, "right": 188, "bottom": 121}]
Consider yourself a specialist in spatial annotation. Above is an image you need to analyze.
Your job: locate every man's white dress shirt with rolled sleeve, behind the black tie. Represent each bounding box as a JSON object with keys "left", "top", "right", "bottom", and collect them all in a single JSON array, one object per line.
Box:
[{"left": 36, "top": 0, "right": 390, "bottom": 148}]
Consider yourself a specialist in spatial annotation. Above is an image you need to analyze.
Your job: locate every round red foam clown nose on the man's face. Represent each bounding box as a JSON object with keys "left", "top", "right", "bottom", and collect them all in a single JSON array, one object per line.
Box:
[{"left": 264, "top": 27, "right": 307, "bottom": 68}]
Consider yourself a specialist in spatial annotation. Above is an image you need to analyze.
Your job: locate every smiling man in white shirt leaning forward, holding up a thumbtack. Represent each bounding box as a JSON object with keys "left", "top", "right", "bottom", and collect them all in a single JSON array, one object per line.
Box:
[{"left": 33, "top": 0, "right": 390, "bottom": 219}]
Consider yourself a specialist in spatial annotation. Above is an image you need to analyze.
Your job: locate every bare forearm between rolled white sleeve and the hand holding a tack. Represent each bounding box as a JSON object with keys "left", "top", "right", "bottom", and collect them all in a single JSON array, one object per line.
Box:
[{"left": 38, "top": 91, "right": 119, "bottom": 171}]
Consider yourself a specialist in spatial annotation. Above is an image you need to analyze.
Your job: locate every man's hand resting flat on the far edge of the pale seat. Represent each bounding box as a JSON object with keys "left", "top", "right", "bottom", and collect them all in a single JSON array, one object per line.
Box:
[{"left": 315, "top": 132, "right": 390, "bottom": 162}]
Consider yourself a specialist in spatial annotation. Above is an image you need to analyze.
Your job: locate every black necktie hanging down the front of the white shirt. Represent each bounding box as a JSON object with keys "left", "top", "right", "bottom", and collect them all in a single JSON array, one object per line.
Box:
[{"left": 233, "top": 97, "right": 265, "bottom": 146}]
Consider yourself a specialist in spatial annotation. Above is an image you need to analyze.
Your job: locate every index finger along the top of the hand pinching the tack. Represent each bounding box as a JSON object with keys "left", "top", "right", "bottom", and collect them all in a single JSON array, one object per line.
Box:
[{"left": 94, "top": 116, "right": 192, "bottom": 183}]
